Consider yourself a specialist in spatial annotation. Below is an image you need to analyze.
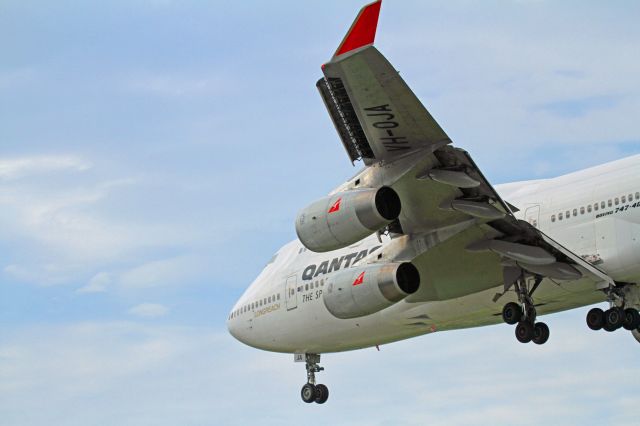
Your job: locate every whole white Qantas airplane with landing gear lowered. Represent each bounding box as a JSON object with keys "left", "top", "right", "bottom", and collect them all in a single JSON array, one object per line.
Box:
[{"left": 227, "top": 0, "right": 640, "bottom": 404}]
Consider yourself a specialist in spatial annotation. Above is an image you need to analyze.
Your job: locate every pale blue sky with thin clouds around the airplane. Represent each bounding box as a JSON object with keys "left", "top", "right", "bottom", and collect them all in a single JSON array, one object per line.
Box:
[{"left": 0, "top": 0, "right": 640, "bottom": 425}]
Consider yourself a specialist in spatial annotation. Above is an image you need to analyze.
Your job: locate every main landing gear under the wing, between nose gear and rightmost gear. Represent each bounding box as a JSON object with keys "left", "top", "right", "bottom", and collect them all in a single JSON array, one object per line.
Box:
[{"left": 502, "top": 276, "right": 549, "bottom": 345}]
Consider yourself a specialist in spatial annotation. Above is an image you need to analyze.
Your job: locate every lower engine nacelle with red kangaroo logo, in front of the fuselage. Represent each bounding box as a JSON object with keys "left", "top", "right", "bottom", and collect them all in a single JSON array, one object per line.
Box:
[{"left": 322, "top": 263, "right": 420, "bottom": 319}]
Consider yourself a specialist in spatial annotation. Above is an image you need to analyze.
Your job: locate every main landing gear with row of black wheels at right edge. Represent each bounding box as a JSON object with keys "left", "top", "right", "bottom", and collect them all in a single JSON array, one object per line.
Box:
[{"left": 587, "top": 286, "right": 640, "bottom": 332}]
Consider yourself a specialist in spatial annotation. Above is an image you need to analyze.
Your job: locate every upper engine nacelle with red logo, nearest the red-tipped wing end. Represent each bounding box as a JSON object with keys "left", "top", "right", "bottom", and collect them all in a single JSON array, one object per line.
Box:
[{"left": 296, "top": 186, "right": 401, "bottom": 252}]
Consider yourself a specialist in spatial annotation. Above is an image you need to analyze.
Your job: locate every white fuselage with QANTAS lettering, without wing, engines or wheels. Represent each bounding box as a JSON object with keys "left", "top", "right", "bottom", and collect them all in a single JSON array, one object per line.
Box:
[{"left": 227, "top": 155, "right": 640, "bottom": 353}]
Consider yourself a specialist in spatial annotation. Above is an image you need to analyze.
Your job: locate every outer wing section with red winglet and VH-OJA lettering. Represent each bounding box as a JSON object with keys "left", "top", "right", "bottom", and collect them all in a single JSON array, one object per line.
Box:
[{"left": 317, "top": 1, "right": 451, "bottom": 165}]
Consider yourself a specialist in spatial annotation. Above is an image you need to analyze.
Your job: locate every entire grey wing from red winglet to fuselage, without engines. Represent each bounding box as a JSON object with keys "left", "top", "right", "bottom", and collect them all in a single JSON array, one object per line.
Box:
[{"left": 317, "top": 1, "right": 614, "bottom": 302}]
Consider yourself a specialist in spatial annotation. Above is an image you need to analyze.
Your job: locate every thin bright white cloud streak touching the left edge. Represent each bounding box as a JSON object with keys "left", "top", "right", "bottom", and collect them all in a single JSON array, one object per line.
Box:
[{"left": 0, "top": 155, "right": 91, "bottom": 180}]
